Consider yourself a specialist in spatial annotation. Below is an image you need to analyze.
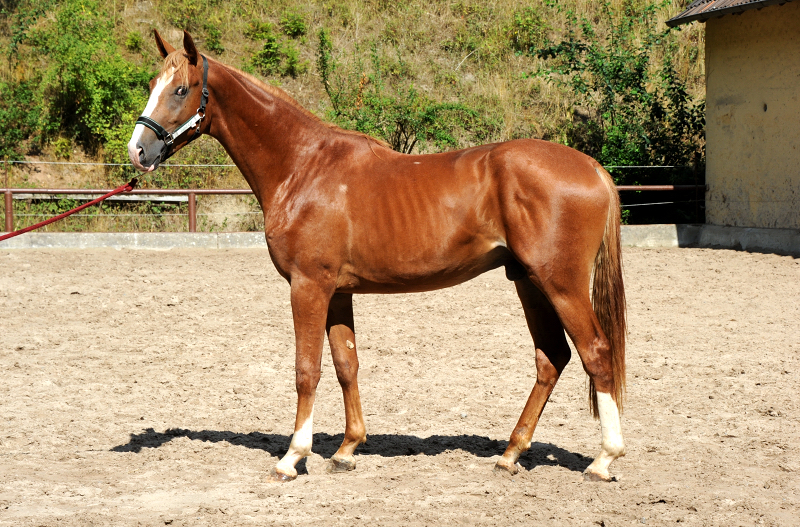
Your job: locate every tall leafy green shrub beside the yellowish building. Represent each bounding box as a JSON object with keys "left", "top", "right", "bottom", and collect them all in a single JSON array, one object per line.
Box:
[{"left": 537, "top": 3, "right": 704, "bottom": 182}]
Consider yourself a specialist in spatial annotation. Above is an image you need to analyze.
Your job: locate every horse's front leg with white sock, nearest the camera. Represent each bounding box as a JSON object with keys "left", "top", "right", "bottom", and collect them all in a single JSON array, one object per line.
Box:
[{"left": 271, "top": 276, "right": 333, "bottom": 481}]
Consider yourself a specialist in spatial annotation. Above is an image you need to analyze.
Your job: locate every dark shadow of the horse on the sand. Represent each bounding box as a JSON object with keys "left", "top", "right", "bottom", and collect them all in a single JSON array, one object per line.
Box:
[{"left": 111, "top": 428, "right": 592, "bottom": 472}]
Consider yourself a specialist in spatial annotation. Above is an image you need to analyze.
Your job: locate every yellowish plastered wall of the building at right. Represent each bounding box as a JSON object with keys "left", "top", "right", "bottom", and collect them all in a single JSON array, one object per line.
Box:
[{"left": 706, "top": 2, "right": 800, "bottom": 229}]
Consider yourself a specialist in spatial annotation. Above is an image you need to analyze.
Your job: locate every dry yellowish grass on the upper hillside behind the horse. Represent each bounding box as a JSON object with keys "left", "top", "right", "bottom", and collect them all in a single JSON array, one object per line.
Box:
[{"left": 120, "top": 0, "right": 705, "bottom": 140}]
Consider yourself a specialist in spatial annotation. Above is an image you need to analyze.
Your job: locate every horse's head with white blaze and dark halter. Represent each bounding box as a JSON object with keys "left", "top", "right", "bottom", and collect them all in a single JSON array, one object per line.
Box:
[{"left": 128, "top": 30, "right": 208, "bottom": 172}]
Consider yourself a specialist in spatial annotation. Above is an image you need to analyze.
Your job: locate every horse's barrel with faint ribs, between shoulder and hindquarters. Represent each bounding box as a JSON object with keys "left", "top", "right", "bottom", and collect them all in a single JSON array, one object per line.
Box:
[{"left": 330, "top": 147, "right": 509, "bottom": 292}]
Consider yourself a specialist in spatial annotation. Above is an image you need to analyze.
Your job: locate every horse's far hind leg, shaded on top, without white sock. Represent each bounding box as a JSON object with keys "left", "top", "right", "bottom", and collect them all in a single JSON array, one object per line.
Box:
[{"left": 495, "top": 278, "right": 570, "bottom": 474}]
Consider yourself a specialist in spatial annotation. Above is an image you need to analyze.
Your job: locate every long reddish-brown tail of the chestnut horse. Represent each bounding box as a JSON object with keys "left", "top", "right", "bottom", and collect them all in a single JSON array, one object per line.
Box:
[{"left": 589, "top": 166, "right": 627, "bottom": 418}]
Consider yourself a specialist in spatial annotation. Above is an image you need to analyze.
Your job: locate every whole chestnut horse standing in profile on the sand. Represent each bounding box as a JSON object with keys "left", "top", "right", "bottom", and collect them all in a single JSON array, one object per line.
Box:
[{"left": 128, "top": 32, "right": 626, "bottom": 481}]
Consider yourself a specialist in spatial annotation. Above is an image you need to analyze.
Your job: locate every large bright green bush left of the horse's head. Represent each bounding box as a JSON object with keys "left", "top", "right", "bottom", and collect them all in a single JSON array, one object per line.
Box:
[{"left": 2, "top": 0, "right": 152, "bottom": 157}]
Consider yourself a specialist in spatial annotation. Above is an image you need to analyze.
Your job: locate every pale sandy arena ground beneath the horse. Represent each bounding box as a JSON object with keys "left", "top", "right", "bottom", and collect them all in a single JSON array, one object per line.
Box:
[{"left": 0, "top": 249, "right": 800, "bottom": 527}]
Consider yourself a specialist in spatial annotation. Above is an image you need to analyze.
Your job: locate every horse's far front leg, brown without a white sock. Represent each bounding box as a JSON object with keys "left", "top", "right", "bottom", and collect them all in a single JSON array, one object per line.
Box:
[{"left": 326, "top": 293, "right": 367, "bottom": 472}]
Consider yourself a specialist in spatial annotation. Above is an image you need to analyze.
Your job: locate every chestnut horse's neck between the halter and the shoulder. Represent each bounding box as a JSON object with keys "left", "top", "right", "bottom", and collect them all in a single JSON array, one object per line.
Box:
[{"left": 209, "top": 70, "right": 327, "bottom": 202}]
